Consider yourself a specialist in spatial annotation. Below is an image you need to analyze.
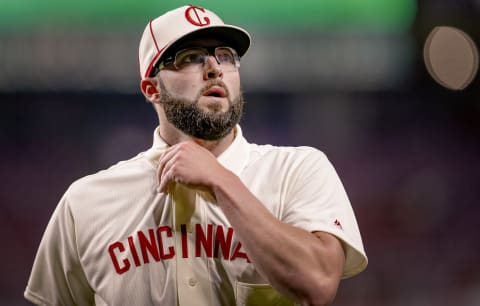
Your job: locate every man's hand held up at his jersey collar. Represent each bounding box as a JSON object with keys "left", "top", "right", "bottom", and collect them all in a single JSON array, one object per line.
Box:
[{"left": 157, "top": 140, "right": 226, "bottom": 192}]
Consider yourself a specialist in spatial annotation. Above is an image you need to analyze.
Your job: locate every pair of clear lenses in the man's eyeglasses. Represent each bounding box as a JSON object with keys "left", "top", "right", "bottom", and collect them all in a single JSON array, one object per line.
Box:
[{"left": 174, "top": 47, "right": 239, "bottom": 71}]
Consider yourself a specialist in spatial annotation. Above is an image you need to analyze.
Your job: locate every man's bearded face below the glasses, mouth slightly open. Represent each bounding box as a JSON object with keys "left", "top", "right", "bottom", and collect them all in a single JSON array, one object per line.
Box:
[{"left": 157, "top": 41, "right": 244, "bottom": 140}]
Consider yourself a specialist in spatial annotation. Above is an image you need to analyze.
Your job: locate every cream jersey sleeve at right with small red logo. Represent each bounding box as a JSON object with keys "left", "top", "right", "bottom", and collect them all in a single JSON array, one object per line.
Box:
[{"left": 283, "top": 149, "right": 368, "bottom": 278}]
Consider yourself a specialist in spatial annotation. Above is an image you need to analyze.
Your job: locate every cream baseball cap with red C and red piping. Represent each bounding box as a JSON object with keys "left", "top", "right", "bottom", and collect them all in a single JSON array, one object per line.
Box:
[{"left": 138, "top": 5, "right": 250, "bottom": 78}]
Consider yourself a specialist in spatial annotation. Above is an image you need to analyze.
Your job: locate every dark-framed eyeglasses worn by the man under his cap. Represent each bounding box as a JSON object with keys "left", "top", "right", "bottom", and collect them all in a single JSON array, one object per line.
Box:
[{"left": 152, "top": 47, "right": 240, "bottom": 75}]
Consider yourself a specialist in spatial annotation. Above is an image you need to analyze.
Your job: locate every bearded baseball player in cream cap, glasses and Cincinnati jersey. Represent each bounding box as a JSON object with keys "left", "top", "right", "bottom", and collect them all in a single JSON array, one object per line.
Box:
[{"left": 25, "top": 5, "right": 367, "bottom": 305}]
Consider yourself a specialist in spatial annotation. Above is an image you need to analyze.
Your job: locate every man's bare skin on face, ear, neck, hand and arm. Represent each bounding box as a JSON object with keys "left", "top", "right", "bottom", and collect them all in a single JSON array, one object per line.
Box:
[{"left": 140, "top": 40, "right": 345, "bottom": 305}]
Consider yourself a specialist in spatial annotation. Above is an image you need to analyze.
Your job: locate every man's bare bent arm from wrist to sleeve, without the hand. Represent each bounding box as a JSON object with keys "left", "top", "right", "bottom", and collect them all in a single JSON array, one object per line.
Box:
[{"left": 212, "top": 172, "right": 344, "bottom": 305}]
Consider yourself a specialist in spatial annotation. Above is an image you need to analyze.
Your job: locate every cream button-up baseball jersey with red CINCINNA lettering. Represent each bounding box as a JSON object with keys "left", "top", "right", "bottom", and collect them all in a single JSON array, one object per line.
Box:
[{"left": 25, "top": 126, "right": 367, "bottom": 306}]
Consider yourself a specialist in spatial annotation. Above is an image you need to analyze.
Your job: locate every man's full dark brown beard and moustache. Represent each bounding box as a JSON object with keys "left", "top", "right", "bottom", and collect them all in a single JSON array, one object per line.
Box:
[{"left": 158, "top": 77, "right": 245, "bottom": 140}]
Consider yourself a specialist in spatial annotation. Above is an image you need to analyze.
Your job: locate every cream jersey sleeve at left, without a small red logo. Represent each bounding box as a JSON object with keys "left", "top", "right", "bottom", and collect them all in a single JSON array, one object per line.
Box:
[{"left": 24, "top": 191, "right": 95, "bottom": 305}]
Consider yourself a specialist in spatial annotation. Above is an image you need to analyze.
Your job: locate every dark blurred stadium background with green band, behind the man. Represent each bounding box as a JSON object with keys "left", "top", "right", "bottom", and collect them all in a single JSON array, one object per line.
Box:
[{"left": 0, "top": 0, "right": 480, "bottom": 306}]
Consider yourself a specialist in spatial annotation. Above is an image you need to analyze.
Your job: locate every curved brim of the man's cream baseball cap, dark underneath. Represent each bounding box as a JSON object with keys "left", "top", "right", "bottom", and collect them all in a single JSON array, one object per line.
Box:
[{"left": 152, "top": 25, "right": 251, "bottom": 72}]
